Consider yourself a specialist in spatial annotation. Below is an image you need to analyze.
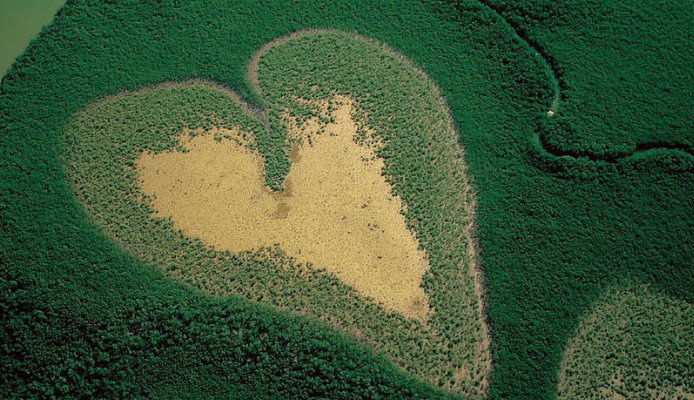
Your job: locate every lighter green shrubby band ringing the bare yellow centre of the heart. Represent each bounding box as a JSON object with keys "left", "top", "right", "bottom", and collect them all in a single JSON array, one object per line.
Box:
[{"left": 66, "top": 28, "right": 489, "bottom": 396}]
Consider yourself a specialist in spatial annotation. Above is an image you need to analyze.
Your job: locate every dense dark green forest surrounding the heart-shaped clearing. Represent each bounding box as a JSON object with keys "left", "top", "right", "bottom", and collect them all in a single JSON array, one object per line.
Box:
[{"left": 0, "top": 0, "right": 694, "bottom": 399}]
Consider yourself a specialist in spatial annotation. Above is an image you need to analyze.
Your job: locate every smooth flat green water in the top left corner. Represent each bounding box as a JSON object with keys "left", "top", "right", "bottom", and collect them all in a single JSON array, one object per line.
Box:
[{"left": 0, "top": 0, "right": 65, "bottom": 76}]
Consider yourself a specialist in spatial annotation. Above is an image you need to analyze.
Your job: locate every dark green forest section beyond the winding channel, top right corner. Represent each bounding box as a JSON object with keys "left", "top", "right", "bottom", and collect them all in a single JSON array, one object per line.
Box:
[{"left": 483, "top": 0, "right": 694, "bottom": 160}]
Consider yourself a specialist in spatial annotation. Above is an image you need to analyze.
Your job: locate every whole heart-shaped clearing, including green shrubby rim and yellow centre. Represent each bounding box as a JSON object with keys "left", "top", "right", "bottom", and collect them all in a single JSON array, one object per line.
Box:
[{"left": 64, "top": 31, "right": 491, "bottom": 397}]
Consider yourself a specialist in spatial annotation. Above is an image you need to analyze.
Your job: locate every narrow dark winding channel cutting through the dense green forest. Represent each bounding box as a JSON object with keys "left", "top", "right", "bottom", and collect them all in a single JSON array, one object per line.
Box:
[{"left": 477, "top": 0, "right": 694, "bottom": 163}]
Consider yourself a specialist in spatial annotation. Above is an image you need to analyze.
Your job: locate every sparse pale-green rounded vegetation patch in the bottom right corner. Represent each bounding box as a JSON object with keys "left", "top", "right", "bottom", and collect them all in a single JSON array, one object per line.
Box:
[{"left": 559, "top": 286, "right": 694, "bottom": 400}]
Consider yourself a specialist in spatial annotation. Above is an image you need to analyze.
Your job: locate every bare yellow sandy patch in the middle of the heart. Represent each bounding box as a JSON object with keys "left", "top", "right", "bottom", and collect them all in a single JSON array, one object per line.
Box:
[{"left": 137, "top": 98, "right": 429, "bottom": 321}]
